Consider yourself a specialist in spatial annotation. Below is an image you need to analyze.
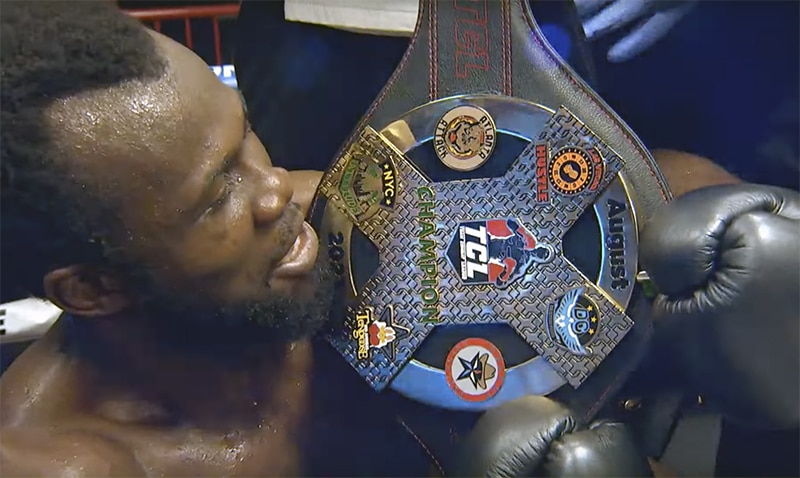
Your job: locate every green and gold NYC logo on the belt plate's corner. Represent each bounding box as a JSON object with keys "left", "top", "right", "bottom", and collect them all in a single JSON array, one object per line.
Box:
[{"left": 338, "top": 157, "right": 397, "bottom": 221}]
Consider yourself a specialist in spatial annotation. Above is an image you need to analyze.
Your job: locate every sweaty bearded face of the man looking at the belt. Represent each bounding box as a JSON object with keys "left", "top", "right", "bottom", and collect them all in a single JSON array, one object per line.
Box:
[{"left": 49, "top": 30, "right": 330, "bottom": 344}]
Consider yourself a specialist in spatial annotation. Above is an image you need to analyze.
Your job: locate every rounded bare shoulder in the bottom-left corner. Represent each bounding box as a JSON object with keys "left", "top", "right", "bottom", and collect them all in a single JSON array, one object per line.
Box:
[{"left": 0, "top": 427, "right": 145, "bottom": 477}]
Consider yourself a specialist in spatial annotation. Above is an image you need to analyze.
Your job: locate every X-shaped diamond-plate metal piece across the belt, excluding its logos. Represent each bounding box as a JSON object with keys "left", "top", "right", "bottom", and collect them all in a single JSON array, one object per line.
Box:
[{"left": 320, "top": 108, "right": 633, "bottom": 390}]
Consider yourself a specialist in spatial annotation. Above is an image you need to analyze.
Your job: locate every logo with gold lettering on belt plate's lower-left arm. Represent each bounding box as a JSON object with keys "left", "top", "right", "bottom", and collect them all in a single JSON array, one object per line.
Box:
[{"left": 352, "top": 306, "right": 410, "bottom": 360}]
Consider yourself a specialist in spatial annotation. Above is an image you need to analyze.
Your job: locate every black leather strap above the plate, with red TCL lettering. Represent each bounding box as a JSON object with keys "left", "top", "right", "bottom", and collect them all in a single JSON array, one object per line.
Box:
[{"left": 345, "top": 0, "right": 671, "bottom": 218}]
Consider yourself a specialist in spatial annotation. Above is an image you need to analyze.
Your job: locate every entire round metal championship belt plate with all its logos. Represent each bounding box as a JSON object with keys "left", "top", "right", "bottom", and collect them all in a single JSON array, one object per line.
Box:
[{"left": 312, "top": 2, "right": 668, "bottom": 410}]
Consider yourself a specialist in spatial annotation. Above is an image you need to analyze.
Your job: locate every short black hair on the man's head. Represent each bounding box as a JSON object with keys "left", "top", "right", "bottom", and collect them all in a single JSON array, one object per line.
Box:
[{"left": 0, "top": 0, "right": 166, "bottom": 302}]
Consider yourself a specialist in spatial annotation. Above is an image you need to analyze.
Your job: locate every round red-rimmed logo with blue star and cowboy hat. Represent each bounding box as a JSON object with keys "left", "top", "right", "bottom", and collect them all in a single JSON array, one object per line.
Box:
[{"left": 444, "top": 338, "right": 506, "bottom": 402}]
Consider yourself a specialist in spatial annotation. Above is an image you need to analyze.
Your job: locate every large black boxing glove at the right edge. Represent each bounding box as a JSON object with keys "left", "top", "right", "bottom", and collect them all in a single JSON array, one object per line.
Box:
[{"left": 640, "top": 184, "right": 800, "bottom": 428}]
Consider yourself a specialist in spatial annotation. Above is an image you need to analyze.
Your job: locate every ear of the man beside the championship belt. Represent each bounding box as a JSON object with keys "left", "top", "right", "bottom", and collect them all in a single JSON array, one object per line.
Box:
[{"left": 44, "top": 265, "right": 133, "bottom": 317}]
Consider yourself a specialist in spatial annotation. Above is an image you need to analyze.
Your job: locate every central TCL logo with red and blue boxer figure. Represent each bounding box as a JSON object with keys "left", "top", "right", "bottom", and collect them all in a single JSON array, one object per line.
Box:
[{"left": 447, "top": 218, "right": 555, "bottom": 288}]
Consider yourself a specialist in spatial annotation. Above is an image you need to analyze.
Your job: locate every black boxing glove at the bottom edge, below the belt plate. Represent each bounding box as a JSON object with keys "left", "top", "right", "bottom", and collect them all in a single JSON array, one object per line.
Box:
[{"left": 453, "top": 395, "right": 652, "bottom": 477}]
